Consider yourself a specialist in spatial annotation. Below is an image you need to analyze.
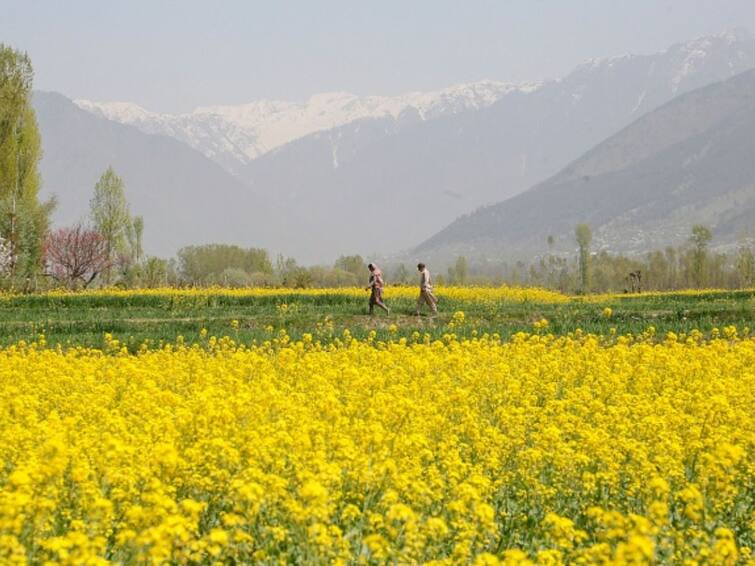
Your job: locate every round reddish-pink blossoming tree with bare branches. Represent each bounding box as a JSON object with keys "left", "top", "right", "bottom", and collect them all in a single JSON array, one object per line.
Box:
[{"left": 44, "top": 224, "right": 108, "bottom": 288}]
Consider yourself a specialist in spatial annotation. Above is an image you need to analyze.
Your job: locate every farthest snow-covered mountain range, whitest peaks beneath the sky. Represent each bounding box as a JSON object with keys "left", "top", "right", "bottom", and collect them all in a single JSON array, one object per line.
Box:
[{"left": 75, "top": 81, "right": 539, "bottom": 172}]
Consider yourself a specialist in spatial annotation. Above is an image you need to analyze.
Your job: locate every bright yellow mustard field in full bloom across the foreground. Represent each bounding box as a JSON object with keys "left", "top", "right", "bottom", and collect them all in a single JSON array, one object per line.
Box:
[{"left": 0, "top": 291, "right": 755, "bottom": 565}]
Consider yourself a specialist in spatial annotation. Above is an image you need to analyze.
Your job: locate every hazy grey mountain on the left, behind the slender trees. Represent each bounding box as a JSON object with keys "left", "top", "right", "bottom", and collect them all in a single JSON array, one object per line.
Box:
[{"left": 34, "top": 92, "right": 270, "bottom": 255}]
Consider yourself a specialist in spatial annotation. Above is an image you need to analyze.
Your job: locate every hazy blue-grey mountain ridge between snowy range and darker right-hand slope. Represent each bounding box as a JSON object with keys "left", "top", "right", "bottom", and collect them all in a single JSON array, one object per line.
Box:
[{"left": 239, "top": 32, "right": 755, "bottom": 258}]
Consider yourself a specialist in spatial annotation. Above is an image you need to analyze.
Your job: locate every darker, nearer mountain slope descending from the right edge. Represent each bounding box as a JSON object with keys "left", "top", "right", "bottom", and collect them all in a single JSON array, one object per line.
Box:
[{"left": 415, "top": 71, "right": 755, "bottom": 256}]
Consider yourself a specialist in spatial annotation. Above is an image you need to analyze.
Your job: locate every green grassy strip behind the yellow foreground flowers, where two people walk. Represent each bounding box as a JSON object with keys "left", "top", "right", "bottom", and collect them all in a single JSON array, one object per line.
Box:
[{"left": 0, "top": 288, "right": 755, "bottom": 350}]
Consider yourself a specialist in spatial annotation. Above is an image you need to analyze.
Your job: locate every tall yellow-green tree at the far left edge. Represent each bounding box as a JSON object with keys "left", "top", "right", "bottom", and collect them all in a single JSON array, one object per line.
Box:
[{"left": 0, "top": 44, "right": 55, "bottom": 279}]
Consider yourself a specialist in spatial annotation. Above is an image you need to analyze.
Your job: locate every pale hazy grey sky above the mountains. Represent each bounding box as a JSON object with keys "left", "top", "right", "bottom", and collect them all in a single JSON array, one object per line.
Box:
[{"left": 0, "top": 0, "right": 755, "bottom": 112}]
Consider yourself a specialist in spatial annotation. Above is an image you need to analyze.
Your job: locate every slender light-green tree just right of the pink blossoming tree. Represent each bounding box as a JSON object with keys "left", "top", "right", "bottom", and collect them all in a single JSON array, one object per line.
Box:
[{"left": 90, "top": 167, "right": 132, "bottom": 285}]
